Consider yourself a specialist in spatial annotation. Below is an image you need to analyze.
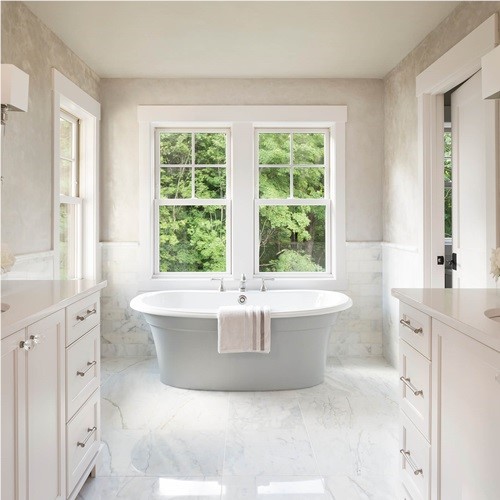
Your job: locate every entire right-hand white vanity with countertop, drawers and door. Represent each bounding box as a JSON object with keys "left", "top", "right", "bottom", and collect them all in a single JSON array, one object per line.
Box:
[{"left": 393, "top": 289, "right": 500, "bottom": 500}]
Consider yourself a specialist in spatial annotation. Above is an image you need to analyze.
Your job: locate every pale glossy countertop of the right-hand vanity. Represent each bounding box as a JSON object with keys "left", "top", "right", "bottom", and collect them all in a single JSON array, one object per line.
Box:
[{"left": 392, "top": 288, "right": 500, "bottom": 352}]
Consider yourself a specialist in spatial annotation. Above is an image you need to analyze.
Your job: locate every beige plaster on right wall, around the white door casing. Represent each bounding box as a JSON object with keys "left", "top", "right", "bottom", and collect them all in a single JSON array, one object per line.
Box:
[{"left": 383, "top": 2, "right": 500, "bottom": 245}]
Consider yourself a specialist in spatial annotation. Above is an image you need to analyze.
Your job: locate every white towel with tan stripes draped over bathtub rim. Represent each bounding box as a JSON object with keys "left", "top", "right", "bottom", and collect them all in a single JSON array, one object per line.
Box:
[{"left": 217, "top": 306, "right": 271, "bottom": 353}]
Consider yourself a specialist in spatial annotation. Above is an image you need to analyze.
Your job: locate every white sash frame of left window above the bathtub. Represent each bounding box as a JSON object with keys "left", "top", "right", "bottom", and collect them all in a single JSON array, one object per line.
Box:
[{"left": 153, "top": 127, "right": 232, "bottom": 279}]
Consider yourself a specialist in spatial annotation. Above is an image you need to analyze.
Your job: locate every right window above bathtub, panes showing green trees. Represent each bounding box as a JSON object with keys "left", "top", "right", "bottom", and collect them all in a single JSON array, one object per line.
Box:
[{"left": 255, "top": 129, "right": 330, "bottom": 273}]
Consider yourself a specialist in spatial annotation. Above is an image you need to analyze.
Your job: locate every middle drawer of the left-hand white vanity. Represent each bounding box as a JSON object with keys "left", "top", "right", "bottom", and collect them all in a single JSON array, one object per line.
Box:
[{"left": 66, "top": 326, "right": 101, "bottom": 421}]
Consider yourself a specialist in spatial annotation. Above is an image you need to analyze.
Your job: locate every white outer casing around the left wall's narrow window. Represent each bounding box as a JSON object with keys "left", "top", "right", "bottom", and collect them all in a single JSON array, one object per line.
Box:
[{"left": 52, "top": 68, "right": 101, "bottom": 280}]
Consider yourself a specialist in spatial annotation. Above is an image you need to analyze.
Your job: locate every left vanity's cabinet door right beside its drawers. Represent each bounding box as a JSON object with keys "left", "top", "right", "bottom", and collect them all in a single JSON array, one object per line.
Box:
[{"left": 27, "top": 311, "right": 64, "bottom": 500}]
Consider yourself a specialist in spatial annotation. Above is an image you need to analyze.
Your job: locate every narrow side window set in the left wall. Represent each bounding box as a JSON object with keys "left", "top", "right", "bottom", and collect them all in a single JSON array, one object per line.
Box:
[{"left": 59, "top": 110, "right": 82, "bottom": 279}]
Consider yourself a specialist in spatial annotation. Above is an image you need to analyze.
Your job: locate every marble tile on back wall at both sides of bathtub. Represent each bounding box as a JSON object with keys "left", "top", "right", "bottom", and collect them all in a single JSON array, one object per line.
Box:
[{"left": 101, "top": 242, "right": 382, "bottom": 357}]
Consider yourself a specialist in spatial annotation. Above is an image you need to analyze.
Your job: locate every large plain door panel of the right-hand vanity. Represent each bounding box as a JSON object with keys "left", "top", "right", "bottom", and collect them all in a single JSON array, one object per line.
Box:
[{"left": 434, "top": 321, "right": 500, "bottom": 500}]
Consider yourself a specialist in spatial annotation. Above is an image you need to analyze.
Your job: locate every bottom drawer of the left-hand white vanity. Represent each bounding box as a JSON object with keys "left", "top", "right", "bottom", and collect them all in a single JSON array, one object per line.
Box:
[{"left": 66, "top": 390, "right": 100, "bottom": 496}]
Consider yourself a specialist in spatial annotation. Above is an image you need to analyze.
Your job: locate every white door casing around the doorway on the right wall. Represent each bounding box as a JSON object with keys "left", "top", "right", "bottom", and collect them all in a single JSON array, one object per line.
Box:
[{"left": 416, "top": 13, "right": 498, "bottom": 287}]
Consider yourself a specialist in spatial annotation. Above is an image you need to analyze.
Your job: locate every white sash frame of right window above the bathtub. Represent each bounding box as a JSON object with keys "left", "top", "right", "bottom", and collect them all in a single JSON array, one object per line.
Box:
[{"left": 254, "top": 127, "right": 334, "bottom": 278}]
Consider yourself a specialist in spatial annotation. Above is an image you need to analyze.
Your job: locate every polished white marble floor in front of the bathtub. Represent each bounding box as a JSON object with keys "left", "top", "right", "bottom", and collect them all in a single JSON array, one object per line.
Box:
[{"left": 77, "top": 358, "right": 399, "bottom": 500}]
